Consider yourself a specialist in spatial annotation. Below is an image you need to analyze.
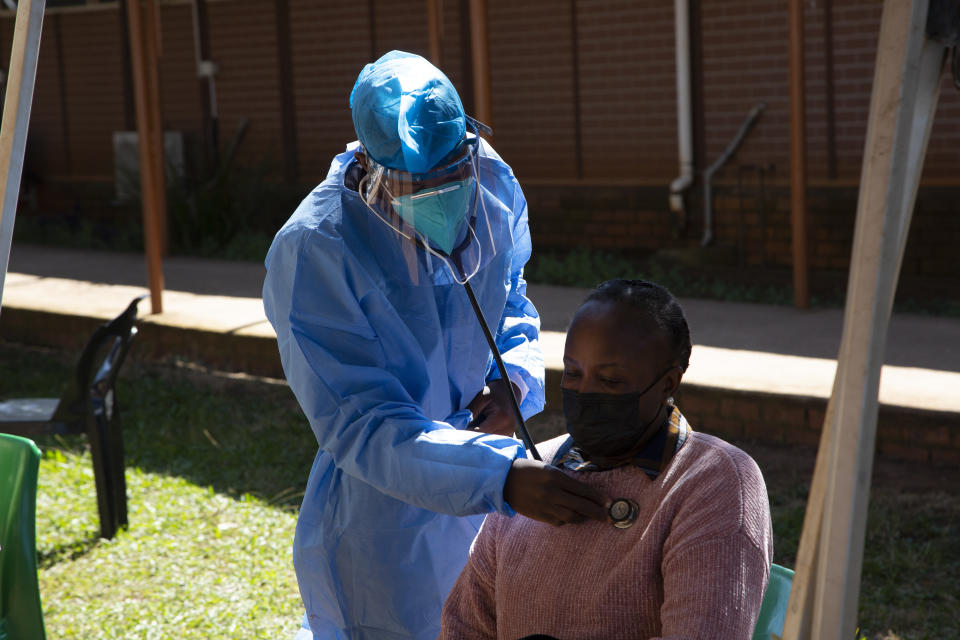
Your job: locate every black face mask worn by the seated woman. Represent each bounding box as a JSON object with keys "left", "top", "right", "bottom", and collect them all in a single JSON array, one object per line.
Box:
[{"left": 561, "top": 367, "right": 673, "bottom": 458}]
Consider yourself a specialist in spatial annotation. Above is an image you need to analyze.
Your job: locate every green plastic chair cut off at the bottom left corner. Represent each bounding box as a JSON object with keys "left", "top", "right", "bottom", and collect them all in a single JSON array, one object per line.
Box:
[{"left": 0, "top": 433, "right": 46, "bottom": 640}]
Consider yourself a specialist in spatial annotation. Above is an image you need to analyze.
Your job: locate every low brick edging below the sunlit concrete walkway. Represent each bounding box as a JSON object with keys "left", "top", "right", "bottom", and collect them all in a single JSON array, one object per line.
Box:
[{"left": 0, "top": 307, "right": 960, "bottom": 465}]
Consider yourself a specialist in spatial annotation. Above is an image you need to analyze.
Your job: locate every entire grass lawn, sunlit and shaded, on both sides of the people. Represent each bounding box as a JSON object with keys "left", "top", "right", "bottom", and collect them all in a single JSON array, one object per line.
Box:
[{"left": 0, "top": 342, "right": 960, "bottom": 640}]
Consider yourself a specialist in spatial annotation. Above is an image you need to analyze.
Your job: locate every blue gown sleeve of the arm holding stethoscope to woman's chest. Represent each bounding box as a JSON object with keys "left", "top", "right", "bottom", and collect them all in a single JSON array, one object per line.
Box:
[{"left": 264, "top": 222, "right": 525, "bottom": 515}]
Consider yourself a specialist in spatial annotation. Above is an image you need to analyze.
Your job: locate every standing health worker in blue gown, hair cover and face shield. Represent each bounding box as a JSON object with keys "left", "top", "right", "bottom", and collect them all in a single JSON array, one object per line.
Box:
[{"left": 263, "top": 51, "right": 606, "bottom": 640}]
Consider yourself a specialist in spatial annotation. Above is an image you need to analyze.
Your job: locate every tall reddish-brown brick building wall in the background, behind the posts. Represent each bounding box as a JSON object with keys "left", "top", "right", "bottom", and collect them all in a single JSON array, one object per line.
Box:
[{"left": 0, "top": 0, "right": 960, "bottom": 277}]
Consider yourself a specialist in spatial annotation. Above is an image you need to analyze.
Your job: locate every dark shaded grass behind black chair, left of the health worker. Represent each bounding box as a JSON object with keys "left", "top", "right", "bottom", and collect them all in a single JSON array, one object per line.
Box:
[{"left": 0, "top": 343, "right": 317, "bottom": 508}]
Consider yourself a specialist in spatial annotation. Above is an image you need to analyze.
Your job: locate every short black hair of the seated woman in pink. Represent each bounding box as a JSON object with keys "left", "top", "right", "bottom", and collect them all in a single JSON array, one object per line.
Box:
[{"left": 585, "top": 278, "right": 691, "bottom": 371}]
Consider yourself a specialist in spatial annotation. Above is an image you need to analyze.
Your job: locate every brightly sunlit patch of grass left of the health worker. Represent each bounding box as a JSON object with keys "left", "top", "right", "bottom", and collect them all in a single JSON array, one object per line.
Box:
[{"left": 37, "top": 449, "right": 303, "bottom": 638}]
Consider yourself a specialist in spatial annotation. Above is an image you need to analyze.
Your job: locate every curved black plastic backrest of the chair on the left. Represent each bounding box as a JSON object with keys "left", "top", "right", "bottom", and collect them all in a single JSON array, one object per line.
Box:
[{"left": 52, "top": 295, "right": 147, "bottom": 422}]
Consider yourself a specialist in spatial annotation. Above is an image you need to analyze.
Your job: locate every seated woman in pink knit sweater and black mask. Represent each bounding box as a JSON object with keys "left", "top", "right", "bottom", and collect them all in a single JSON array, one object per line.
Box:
[{"left": 441, "top": 280, "right": 773, "bottom": 640}]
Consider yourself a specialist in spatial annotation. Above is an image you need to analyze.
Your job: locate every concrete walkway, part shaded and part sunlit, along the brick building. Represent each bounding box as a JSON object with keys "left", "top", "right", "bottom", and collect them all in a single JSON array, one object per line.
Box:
[{"left": 0, "top": 245, "right": 960, "bottom": 413}]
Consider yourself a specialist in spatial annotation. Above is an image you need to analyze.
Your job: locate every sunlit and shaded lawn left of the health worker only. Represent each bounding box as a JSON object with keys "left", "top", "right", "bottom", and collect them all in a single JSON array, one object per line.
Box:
[{"left": 0, "top": 343, "right": 316, "bottom": 640}]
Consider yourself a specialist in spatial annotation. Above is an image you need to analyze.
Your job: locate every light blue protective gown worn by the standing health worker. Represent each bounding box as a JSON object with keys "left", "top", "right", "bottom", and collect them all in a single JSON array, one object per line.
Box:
[{"left": 263, "top": 138, "right": 544, "bottom": 640}]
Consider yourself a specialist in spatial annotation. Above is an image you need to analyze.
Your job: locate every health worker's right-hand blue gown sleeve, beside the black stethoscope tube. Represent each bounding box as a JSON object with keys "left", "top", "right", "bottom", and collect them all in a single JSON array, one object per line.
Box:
[{"left": 487, "top": 180, "right": 545, "bottom": 420}]
